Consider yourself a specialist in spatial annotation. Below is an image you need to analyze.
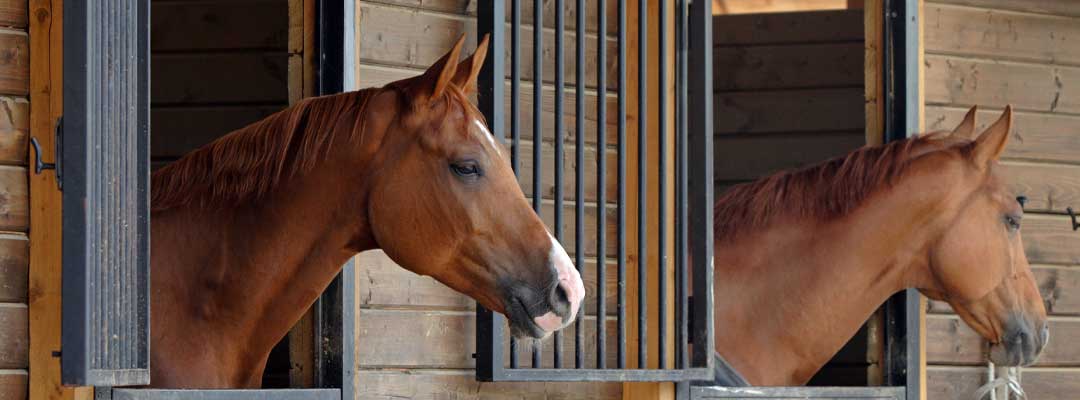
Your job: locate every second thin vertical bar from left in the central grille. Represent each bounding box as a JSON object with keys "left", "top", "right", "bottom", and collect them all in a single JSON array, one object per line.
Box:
[{"left": 533, "top": 0, "right": 544, "bottom": 368}]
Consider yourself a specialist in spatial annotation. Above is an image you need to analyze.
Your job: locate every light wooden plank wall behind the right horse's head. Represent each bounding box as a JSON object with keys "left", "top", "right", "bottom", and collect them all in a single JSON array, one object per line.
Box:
[{"left": 924, "top": 0, "right": 1080, "bottom": 399}]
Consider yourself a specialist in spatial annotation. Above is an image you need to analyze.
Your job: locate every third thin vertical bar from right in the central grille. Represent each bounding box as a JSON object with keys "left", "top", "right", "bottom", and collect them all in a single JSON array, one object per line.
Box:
[{"left": 637, "top": 0, "right": 649, "bottom": 369}]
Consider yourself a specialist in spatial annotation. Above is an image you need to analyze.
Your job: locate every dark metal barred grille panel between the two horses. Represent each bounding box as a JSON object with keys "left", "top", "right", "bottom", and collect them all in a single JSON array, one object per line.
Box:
[{"left": 476, "top": 0, "right": 713, "bottom": 381}]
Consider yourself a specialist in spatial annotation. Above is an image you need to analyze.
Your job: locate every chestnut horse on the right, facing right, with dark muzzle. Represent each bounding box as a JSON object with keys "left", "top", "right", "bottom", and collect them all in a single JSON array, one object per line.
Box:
[{"left": 714, "top": 107, "right": 1050, "bottom": 386}]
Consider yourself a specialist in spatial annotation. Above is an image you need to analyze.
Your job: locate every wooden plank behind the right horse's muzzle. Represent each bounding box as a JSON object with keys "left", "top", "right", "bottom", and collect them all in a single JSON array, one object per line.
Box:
[{"left": 927, "top": 315, "right": 1080, "bottom": 366}]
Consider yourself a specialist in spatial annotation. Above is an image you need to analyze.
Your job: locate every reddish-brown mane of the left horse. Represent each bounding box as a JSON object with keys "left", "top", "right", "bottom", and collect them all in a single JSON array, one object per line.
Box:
[{"left": 150, "top": 89, "right": 380, "bottom": 212}]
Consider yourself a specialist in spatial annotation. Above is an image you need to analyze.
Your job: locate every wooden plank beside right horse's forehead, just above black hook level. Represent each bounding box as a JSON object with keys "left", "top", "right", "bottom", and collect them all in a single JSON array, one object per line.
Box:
[{"left": 999, "top": 161, "right": 1080, "bottom": 213}]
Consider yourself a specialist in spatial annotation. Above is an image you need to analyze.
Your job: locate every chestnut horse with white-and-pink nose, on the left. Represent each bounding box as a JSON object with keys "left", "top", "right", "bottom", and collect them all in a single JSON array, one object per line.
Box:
[{"left": 150, "top": 36, "right": 584, "bottom": 388}]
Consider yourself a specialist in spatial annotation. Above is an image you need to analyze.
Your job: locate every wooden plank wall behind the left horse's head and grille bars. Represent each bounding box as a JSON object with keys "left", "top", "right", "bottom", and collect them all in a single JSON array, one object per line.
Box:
[{"left": 357, "top": 0, "right": 622, "bottom": 399}]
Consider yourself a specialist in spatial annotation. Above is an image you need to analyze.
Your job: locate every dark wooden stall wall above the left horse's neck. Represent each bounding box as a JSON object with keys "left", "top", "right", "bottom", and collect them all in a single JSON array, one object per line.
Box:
[{"left": 150, "top": 0, "right": 288, "bottom": 166}]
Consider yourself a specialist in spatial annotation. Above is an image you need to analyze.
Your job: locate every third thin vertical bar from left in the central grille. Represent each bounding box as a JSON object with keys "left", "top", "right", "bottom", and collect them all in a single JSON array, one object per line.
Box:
[{"left": 552, "top": 0, "right": 581, "bottom": 368}]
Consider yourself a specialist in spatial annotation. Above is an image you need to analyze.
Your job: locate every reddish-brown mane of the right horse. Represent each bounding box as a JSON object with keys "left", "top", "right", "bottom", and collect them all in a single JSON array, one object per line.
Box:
[{"left": 713, "top": 134, "right": 956, "bottom": 241}]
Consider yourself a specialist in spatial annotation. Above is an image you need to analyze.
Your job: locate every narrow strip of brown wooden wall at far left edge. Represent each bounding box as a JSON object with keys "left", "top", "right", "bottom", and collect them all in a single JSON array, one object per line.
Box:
[{"left": 0, "top": 0, "right": 30, "bottom": 400}]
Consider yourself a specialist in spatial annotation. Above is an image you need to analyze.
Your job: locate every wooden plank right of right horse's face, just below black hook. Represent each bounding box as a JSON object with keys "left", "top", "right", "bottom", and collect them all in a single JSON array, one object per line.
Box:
[{"left": 1021, "top": 214, "right": 1080, "bottom": 265}]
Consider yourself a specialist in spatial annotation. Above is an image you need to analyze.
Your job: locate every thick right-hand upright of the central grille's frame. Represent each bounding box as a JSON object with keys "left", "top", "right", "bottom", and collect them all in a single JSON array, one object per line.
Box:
[{"left": 687, "top": 1, "right": 715, "bottom": 368}]
